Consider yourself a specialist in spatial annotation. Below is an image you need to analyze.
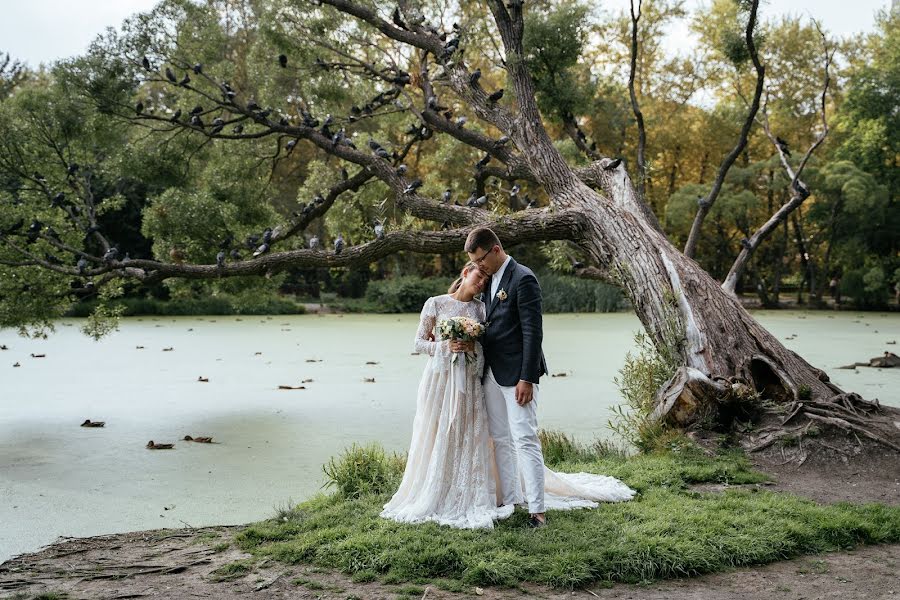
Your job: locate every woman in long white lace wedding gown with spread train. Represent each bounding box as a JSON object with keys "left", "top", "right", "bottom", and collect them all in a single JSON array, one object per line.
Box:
[{"left": 381, "top": 262, "right": 635, "bottom": 529}]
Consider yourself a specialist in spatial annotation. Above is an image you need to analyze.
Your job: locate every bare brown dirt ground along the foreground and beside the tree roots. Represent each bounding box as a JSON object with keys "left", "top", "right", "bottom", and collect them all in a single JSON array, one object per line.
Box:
[{"left": 0, "top": 456, "right": 900, "bottom": 600}]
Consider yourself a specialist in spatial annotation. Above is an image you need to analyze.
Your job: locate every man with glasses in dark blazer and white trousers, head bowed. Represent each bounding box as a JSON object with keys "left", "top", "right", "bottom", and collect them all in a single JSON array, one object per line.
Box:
[{"left": 465, "top": 227, "right": 547, "bottom": 527}]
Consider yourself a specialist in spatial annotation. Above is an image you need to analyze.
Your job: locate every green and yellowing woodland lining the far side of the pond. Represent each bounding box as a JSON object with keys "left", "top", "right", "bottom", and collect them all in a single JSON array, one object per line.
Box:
[{"left": 0, "top": 0, "right": 900, "bottom": 328}]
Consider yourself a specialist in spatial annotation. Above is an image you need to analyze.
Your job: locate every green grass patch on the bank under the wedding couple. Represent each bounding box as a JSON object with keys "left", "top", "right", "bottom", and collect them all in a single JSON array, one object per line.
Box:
[{"left": 230, "top": 436, "right": 900, "bottom": 590}]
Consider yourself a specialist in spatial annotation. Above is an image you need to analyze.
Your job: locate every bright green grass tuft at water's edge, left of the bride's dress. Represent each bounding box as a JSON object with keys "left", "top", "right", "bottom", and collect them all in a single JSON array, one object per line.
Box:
[{"left": 323, "top": 443, "right": 406, "bottom": 499}]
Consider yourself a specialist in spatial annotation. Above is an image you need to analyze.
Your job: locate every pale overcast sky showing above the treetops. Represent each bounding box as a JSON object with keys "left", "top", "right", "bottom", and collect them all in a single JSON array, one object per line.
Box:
[{"left": 0, "top": 0, "right": 890, "bottom": 66}]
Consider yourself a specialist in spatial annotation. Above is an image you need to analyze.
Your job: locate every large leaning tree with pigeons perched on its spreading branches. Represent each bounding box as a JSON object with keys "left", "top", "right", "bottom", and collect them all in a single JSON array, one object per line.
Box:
[{"left": 2, "top": 0, "right": 900, "bottom": 449}]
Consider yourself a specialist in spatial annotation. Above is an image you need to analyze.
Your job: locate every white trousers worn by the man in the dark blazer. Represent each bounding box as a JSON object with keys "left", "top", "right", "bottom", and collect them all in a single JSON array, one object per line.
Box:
[{"left": 484, "top": 368, "right": 544, "bottom": 514}]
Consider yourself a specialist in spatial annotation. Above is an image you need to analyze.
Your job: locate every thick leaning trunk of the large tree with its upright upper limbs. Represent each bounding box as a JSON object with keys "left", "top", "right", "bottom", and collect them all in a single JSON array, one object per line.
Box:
[{"left": 472, "top": 0, "right": 840, "bottom": 422}]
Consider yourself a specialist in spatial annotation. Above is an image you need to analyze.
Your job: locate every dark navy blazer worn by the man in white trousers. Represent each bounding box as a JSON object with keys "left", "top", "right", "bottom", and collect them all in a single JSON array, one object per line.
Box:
[{"left": 481, "top": 258, "right": 547, "bottom": 386}]
